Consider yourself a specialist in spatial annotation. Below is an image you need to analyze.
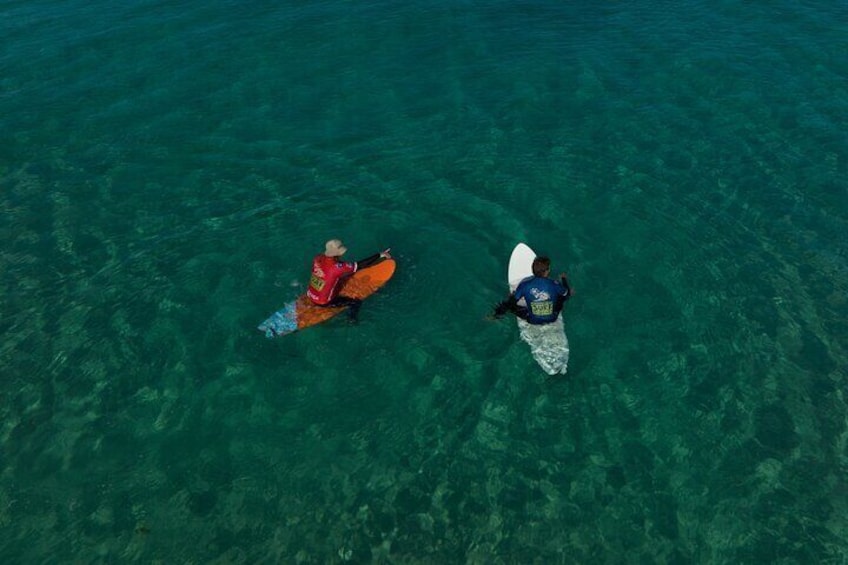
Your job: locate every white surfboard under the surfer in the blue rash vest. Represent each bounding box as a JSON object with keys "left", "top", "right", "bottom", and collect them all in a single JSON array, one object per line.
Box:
[{"left": 507, "top": 243, "right": 569, "bottom": 375}]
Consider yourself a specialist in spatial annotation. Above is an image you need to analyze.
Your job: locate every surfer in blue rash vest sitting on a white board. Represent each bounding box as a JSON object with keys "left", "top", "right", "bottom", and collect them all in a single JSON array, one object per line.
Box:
[{"left": 494, "top": 256, "right": 574, "bottom": 324}]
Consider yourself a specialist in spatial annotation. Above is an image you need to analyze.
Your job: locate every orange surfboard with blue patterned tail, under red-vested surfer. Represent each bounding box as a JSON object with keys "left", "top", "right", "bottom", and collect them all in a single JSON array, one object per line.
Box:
[{"left": 257, "top": 259, "right": 397, "bottom": 337}]
